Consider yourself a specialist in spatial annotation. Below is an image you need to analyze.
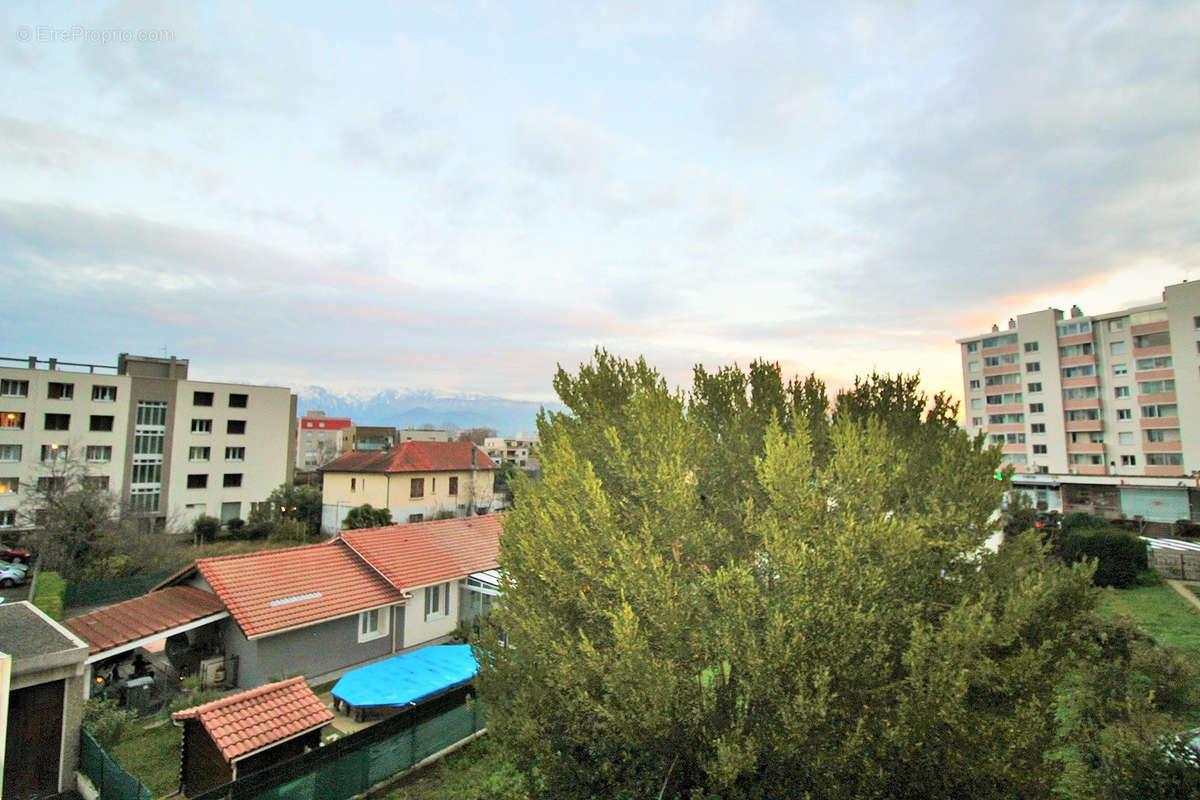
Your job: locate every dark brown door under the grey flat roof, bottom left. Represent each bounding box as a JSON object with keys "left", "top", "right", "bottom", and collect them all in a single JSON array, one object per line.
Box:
[{"left": 4, "top": 680, "right": 64, "bottom": 800}]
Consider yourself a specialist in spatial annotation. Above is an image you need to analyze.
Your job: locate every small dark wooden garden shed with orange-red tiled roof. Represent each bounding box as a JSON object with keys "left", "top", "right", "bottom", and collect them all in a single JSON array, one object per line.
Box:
[{"left": 172, "top": 678, "right": 334, "bottom": 795}]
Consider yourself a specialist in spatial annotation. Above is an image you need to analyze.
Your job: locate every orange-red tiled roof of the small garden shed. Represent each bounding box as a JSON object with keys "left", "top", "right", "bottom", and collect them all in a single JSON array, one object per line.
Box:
[{"left": 170, "top": 678, "right": 334, "bottom": 762}]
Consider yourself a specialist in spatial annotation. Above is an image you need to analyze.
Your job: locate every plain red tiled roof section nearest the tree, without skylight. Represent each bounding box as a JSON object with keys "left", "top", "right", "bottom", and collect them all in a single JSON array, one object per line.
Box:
[{"left": 338, "top": 513, "right": 504, "bottom": 589}]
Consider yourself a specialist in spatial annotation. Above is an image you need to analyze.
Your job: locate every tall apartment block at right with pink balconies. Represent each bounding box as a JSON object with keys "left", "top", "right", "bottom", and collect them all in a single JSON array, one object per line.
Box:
[{"left": 958, "top": 282, "right": 1200, "bottom": 522}]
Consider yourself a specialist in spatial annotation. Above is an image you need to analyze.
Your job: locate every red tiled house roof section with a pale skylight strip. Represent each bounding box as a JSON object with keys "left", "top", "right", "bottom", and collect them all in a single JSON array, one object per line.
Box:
[{"left": 196, "top": 540, "right": 403, "bottom": 638}]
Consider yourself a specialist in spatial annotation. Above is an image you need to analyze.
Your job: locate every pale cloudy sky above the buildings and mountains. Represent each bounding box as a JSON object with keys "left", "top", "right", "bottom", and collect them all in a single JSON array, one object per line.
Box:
[{"left": 0, "top": 0, "right": 1200, "bottom": 401}]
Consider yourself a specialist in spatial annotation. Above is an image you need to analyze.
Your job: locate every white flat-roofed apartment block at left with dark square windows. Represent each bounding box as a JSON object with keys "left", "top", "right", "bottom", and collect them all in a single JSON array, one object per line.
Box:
[{"left": 0, "top": 353, "right": 296, "bottom": 529}]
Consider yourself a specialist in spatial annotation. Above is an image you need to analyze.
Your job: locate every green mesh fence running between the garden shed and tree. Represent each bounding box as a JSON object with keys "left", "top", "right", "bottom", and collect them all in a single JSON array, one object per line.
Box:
[{"left": 191, "top": 687, "right": 484, "bottom": 800}]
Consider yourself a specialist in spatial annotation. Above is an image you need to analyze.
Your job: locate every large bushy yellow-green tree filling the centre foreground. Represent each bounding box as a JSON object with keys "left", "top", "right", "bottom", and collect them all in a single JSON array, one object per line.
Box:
[{"left": 479, "top": 351, "right": 1190, "bottom": 798}]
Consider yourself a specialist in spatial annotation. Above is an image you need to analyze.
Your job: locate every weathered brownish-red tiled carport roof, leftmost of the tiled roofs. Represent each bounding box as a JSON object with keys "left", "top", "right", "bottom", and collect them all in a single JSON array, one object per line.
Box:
[{"left": 62, "top": 587, "right": 224, "bottom": 654}]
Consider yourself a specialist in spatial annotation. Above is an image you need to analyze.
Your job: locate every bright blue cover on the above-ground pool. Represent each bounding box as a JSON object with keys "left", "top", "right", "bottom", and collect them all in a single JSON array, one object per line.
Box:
[{"left": 332, "top": 644, "right": 479, "bottom": 708}]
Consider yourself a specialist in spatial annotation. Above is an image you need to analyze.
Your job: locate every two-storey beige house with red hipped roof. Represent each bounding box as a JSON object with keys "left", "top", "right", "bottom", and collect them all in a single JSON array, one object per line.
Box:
[{"left": 320, "top": 441, "right": 499, "bottom": 534}]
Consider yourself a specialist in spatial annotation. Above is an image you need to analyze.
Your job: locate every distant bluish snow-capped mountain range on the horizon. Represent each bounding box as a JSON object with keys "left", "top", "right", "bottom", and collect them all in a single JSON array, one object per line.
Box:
[{"left": 296, "top": 386, "right": 564, "bottom": 435}]
